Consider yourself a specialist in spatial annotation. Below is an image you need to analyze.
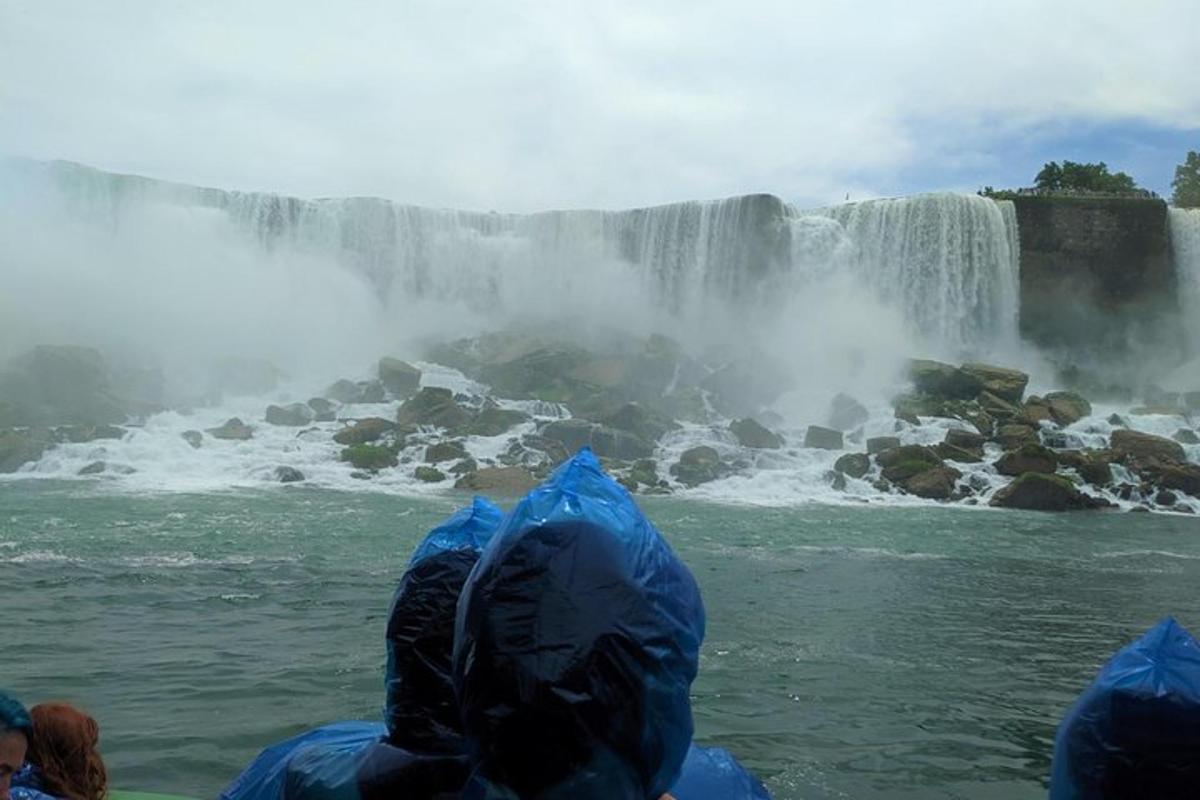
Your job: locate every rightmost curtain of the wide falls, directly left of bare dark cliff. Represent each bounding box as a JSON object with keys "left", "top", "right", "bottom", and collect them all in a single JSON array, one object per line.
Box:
[{"left": 806, "top": 193, "right": 1020, "bottom": 353}]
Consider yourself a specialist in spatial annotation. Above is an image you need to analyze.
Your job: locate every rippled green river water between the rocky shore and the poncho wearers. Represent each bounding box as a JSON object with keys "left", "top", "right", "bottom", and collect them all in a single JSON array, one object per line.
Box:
[{"left": 0, "top": 483, "right": 1200, "bottom": 800}]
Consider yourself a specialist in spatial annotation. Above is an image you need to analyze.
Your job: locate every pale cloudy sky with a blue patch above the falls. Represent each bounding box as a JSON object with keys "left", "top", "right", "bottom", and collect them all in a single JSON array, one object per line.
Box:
[{"left": 0, "top": 0, "right": 1200, "bottom": 211}]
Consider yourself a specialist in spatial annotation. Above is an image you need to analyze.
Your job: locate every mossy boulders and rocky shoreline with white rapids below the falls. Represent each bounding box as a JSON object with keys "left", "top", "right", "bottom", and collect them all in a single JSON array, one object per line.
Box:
[{"left": 0, "top": 333, "right": 1200, "bottom": 512}]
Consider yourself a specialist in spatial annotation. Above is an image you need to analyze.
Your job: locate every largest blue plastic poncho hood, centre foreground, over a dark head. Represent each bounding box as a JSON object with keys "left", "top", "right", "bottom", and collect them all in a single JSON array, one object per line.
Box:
[{"left": 454, "top": 449, "right": 704, "bottom": 800}]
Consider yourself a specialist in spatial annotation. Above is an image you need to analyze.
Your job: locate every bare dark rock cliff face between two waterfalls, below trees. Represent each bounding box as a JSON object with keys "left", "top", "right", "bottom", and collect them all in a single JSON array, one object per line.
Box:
[{"left": 1014, "top": 197, "right": 1181, "bottom": 355}]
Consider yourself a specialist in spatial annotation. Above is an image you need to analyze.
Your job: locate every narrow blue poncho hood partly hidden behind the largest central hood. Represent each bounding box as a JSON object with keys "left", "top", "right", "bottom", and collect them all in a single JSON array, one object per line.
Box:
[{"left": 385, "top": 498, "right": 504, "bottom": 753}]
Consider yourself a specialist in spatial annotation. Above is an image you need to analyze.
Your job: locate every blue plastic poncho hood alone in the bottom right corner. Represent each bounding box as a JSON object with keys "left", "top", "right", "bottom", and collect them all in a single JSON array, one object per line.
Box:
[{"left": 1050, "top": 618, "right": 1200, "bottom": 800}]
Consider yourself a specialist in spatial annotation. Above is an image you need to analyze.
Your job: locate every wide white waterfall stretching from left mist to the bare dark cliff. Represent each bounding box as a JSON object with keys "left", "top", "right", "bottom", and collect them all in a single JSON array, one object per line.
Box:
[{"left": 7, "top": 162, "right": 1018, "bottom": 351}]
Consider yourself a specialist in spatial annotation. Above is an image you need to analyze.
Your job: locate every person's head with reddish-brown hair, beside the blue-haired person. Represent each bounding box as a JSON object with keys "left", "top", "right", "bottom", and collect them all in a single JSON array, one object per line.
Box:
[{"left": 26, "top": 703, "right": 108, "bottom": 800}]
